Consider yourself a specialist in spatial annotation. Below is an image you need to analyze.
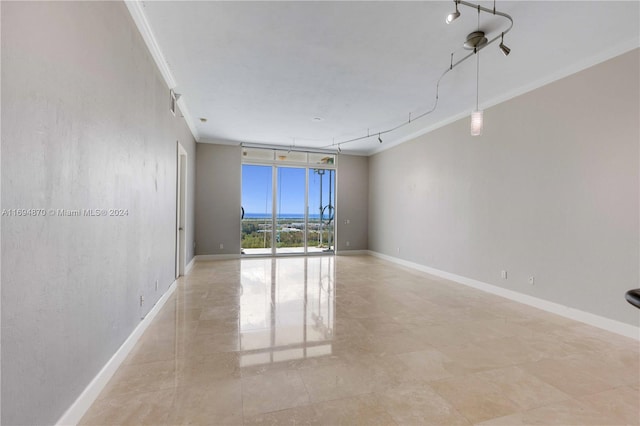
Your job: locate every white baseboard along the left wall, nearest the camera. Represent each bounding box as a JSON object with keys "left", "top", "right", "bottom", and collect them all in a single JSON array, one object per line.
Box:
[{"left": 56, "top": 281, "right": 178, "bottom": 425}]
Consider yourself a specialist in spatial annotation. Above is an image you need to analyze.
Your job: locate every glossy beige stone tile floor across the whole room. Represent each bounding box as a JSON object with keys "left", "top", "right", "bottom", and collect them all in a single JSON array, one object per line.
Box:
[{"left": 81, "top": 256, "right": 640, "bottom": 425}]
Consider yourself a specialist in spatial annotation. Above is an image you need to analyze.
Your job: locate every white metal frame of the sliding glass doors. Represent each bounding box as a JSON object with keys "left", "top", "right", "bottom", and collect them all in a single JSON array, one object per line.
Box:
[{"left": 240, "top": 148, "right": 338, "bottom": 257}]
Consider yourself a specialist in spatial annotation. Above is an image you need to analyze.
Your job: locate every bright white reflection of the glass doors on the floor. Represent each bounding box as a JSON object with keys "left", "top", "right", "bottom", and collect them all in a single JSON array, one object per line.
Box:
[{"left": 240, "top": 257, "right": 335, "bottom": 367}]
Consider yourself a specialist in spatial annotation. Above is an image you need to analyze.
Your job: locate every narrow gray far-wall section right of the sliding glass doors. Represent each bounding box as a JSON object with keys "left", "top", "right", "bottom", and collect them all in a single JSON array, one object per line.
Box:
[{"left": 336, "top": 155, "right": 369, "bottom": 252}]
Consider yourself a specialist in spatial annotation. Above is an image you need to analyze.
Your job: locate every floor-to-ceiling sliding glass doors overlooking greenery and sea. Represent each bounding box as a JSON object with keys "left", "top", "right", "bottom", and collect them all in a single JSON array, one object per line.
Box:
[{"left": 240, "top": 148, "right": 336, "bottom": 256}]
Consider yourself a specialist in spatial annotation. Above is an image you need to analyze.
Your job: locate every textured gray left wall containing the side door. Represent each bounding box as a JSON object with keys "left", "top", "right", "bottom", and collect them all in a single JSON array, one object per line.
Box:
[{"left": 1, "top": 2, "right": 195, "bottom": 425}]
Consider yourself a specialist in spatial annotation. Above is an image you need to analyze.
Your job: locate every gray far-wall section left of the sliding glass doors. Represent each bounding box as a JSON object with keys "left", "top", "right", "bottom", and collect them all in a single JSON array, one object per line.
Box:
[{"left": 196, "top": 143, "right": 242, "bottom": 255}]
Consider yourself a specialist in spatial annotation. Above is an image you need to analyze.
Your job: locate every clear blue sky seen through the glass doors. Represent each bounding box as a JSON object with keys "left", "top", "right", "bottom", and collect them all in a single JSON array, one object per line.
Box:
[{"left": 242, "top": 164, "right": 335, "bottom": 215}]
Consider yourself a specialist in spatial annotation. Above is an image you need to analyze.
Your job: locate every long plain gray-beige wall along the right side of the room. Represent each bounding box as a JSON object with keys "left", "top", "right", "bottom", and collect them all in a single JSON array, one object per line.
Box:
[{"left": 369, "top": 50, "right": 640, "bottom": 325}]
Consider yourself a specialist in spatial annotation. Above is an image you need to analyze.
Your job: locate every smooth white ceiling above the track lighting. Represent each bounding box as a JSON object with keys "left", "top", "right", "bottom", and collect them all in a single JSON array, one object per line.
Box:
[{"left": 140, "top": 1, "right": 640, "bottom": 153}]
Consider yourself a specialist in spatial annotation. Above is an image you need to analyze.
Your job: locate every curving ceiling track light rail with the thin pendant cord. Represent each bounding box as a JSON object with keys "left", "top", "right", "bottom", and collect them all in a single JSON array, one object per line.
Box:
[{"left": 322, "top": 0, "right": 513, "bottom": 149}]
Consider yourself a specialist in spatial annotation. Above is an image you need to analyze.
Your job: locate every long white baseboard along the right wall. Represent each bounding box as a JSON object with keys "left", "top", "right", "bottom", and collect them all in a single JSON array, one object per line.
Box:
[{"left": 368, "top": 250, "right": 640, "bottom": 340}]
